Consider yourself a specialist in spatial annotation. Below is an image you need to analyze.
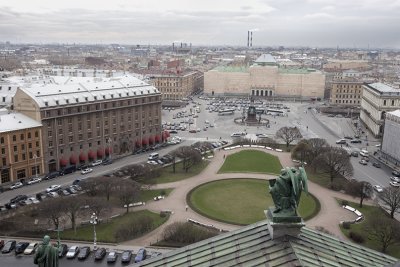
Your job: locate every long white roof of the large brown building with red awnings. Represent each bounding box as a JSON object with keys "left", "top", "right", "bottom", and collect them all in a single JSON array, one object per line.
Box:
[{"left": 16, "top": 75, "right": 159, "bottom": 107}]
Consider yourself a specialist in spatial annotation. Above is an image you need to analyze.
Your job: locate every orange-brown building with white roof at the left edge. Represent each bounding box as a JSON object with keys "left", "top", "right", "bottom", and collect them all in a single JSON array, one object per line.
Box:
[{"left": 0, "top": 112, "right": 44, "bottom": 185}]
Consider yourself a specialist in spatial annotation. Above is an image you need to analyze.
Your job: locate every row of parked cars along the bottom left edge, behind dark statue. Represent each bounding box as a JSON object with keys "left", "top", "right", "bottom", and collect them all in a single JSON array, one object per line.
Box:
[{"left": 0, "top": 240, "right": 153, "bottom": 263}]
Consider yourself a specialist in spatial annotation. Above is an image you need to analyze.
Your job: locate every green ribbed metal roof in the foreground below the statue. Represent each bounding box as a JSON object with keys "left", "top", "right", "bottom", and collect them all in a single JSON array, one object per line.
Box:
[{"left": 132, "top": 220, "right": 397, "bottom": 267}]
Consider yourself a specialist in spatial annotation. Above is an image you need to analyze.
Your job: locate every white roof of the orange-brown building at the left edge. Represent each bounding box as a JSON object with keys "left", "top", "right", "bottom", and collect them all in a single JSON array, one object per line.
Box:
[{"left": 0, "top": 110, "right": 42, "bottom": 133}]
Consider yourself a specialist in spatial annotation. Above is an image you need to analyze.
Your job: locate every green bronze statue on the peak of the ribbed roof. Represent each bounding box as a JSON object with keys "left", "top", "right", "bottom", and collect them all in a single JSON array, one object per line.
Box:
[{"left": 269, "top": 167, "right": 308, "bottom": 216}]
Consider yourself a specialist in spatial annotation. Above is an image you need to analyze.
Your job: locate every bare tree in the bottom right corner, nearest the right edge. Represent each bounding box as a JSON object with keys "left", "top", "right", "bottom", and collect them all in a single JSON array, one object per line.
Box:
[{"left": 364, "top": 212, "right": 400, "bottom": 253}]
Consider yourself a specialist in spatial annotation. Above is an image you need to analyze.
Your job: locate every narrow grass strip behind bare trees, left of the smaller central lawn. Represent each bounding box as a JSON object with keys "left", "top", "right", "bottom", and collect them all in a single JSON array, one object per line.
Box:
[{"left": 148, "top": 160, "right": 210, "bottom": 184}]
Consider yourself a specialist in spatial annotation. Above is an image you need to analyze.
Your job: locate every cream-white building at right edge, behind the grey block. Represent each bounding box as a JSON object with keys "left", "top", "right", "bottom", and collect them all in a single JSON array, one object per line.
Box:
[{"left": 360, "top": 83, "right": 400, "bottom": 137}]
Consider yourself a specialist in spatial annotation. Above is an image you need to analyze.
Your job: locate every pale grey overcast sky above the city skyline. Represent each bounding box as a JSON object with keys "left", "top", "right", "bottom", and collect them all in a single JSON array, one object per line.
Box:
[{"left": 0, "top": 0, "right": 400, "bottom": 48}]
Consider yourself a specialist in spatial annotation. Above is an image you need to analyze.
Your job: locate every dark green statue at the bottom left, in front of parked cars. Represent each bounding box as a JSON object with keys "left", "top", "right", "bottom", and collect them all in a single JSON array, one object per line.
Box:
[{"left": 33, "top": 235, "right": 60, "bottom": 267}]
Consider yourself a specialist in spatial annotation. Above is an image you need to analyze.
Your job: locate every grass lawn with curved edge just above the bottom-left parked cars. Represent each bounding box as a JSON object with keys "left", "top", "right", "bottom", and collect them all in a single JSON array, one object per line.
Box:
[{"left": 60, "top": 210, "right": 168, "bottom": 243}]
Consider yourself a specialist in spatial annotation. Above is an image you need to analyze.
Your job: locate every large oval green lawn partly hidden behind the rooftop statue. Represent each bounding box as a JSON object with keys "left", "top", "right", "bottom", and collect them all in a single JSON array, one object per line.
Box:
[{"left": 187, "top": 179, "right": 320, "bottom": 225}]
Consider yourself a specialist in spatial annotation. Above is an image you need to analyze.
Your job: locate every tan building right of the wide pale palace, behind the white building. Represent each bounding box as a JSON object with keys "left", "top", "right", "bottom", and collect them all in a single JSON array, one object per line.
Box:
[{"left": 330, "top": 81, "right": 363, "bottom": 107}]
